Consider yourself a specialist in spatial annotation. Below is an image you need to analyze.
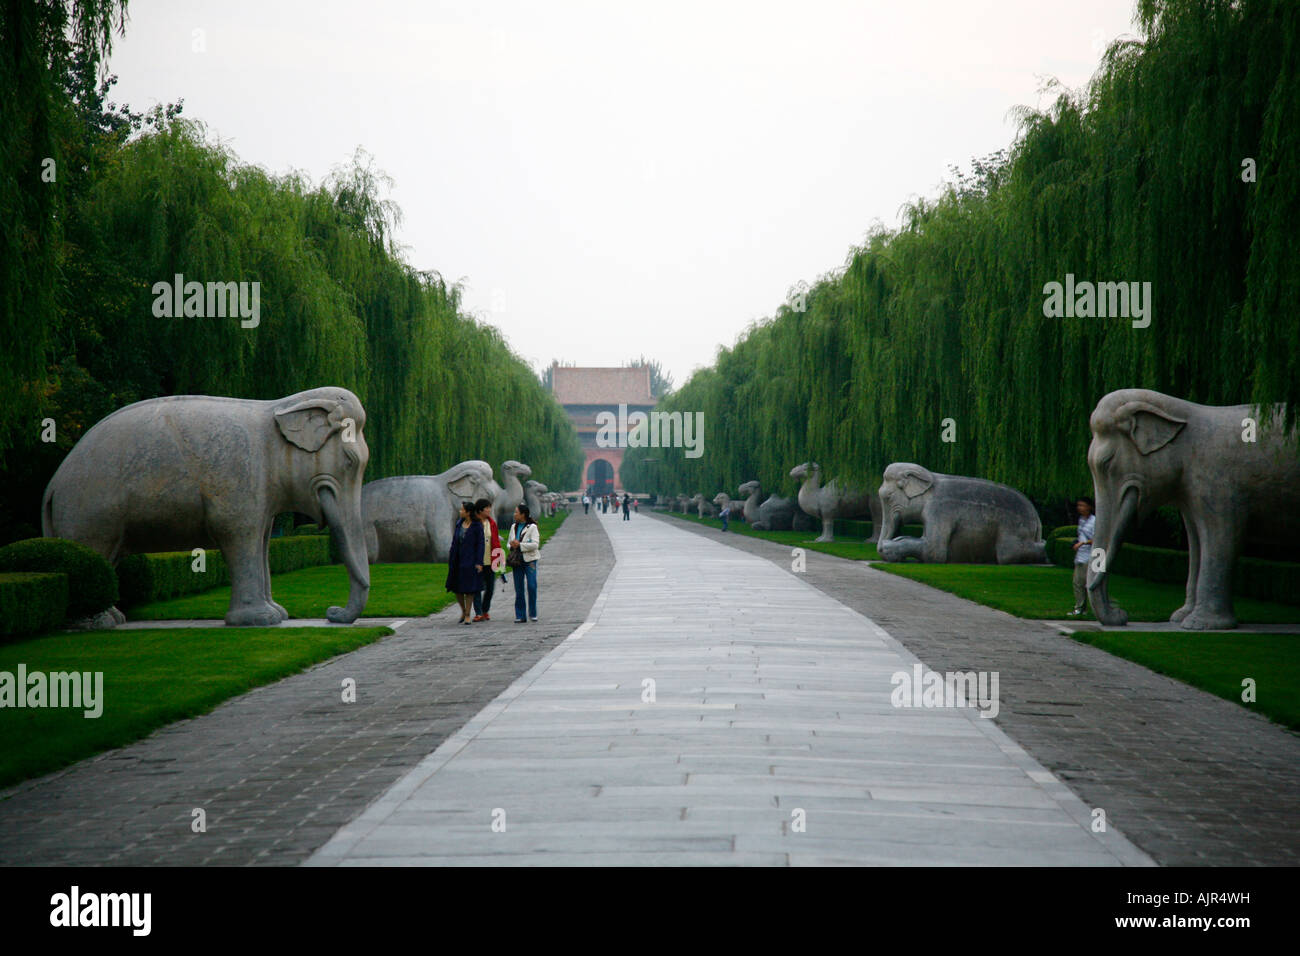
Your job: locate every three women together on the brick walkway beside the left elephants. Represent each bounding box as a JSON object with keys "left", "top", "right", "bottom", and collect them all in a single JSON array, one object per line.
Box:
[{"left": 447, "top": 498, "right": 541, "bottom": 624}]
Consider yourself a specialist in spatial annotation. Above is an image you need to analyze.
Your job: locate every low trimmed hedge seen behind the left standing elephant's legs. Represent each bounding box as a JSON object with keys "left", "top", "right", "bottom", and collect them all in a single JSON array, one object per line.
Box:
[{"left": 117, "top": 533, "right": 334, "bottom": 607}]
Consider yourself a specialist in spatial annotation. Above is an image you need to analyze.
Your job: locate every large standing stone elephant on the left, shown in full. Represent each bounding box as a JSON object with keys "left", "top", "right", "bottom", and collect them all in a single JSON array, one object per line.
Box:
[{"left": 42, "top": 388, "right": 371, "bottom": 627}]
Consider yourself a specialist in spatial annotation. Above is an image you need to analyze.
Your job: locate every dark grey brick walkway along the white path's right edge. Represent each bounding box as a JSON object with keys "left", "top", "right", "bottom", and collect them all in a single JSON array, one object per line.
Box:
[{"left": 639, "top": 518, "right": 1300, "bottom": 866}]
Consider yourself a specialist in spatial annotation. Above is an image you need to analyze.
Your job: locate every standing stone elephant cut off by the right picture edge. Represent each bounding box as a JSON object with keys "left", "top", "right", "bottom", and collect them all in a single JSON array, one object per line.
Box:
[{"left": 1088, "top": 389, "right": 1300, "bottom": 631}]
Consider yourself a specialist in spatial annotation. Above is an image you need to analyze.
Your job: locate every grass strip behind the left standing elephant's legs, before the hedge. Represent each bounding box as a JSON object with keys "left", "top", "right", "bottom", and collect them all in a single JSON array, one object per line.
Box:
[{"left": 126, "top": 564, "right": 454, "bottom": 620}]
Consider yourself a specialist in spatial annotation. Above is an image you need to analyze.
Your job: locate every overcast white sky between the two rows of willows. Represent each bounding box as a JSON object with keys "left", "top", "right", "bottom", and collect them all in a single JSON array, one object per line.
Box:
[{"left": 109, "top": 0, "right": 1134, "bottom": 385}]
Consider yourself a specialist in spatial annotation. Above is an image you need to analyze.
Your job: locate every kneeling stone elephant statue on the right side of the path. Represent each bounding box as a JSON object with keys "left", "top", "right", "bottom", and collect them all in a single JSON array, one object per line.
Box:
[{"left": 876, "top": 462, "right": 1048, "bottom": 564}]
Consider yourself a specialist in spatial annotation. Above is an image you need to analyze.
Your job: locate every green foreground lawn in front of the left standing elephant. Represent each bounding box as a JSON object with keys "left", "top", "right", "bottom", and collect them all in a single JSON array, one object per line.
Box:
[{"left": 0, "top": 627, "right": 393, "bottom": 787}]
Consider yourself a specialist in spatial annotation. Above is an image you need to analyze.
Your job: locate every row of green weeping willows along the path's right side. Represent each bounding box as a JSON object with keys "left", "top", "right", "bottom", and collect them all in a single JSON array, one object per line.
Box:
[{"left": 621, "top": 0, "right": 1300, "bottom": 515}]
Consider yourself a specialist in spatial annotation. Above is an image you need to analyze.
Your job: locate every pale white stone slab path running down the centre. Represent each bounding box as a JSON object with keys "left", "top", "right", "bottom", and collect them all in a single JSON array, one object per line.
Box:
[{"left": 308, "top": 514, "right": 1151, "bottom": 866}]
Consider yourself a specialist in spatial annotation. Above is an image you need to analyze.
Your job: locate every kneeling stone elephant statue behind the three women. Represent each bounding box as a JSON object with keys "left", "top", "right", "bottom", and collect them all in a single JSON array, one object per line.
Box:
[{"left": 361, "top": 459, "right": 498, "bottom": 564}]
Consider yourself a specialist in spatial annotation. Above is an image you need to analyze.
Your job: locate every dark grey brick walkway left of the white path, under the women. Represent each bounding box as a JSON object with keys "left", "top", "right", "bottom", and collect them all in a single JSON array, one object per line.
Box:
[{"left": 0, "top": 514, "right": 612, "bottom": 865}]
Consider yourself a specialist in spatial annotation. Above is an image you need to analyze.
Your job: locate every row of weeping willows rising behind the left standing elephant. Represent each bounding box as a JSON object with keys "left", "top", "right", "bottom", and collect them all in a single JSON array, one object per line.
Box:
[{"left": 7, "top": 116, "right": 582, "bottom": 538}]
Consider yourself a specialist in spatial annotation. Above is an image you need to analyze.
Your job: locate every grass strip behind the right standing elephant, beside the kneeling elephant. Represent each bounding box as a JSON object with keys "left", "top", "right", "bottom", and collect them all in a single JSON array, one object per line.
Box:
[{"left": 872, "top": 561, "right": 1300, "bottom": 624}]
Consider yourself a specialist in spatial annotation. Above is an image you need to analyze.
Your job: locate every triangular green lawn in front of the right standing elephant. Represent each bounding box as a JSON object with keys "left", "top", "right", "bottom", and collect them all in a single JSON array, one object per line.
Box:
[{"left": 1074, "top": 631, "right": 1300, "bottom": 730}]
